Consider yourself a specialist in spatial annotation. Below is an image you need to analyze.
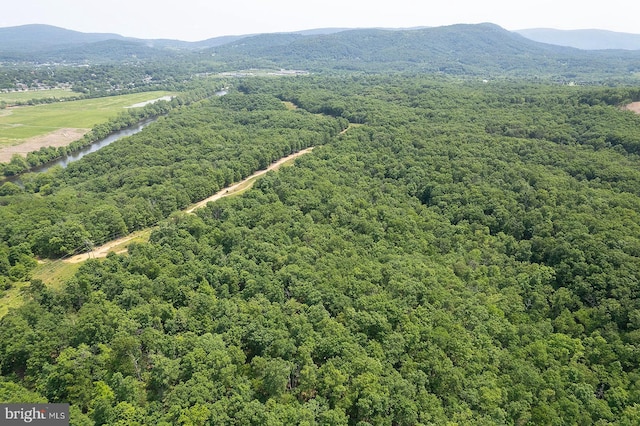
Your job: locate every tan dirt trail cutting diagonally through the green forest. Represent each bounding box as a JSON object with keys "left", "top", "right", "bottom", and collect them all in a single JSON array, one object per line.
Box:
[{"left": 64, "top": 147, "right": 313, "bottom": 263}]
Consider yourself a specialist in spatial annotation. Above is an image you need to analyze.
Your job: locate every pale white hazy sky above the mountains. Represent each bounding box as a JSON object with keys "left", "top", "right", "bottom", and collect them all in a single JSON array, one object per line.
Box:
[{"left": 0, "top": 0, "right": 640, "bottom": 41}]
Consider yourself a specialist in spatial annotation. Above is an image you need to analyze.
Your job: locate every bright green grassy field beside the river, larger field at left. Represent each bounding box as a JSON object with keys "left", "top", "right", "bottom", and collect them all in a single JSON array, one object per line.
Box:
[{"left": 0, "top": 91, "right": 171, "bottom": 147}]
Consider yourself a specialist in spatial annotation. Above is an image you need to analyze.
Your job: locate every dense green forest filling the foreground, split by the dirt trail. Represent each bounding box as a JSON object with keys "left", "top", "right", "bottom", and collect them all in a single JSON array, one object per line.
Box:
[{"left": 0, "top": 74, "right": 640, "bottom": 426}]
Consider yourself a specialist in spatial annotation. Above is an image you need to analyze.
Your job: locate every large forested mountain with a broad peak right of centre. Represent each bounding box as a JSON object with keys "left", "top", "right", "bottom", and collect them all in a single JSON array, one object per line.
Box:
[{"left": 205, "top": 24, "right": 640, "bottom": 81}]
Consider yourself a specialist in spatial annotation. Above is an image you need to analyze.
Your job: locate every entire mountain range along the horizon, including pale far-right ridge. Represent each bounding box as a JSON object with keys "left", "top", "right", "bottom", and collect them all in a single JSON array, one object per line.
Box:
[{"left": 0, "top": 24, "right": 640, "bottom": 80}]
